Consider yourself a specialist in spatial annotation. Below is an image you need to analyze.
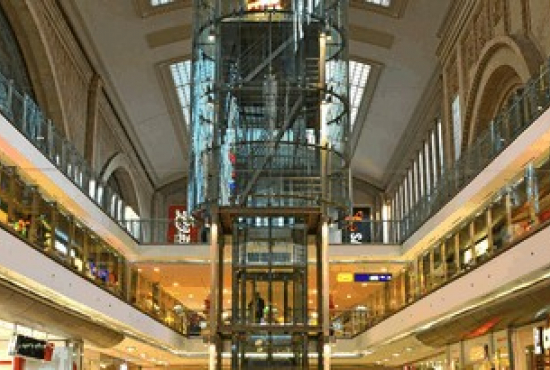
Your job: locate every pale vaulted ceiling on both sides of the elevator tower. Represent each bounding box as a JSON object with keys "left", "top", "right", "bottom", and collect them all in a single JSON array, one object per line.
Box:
[{"left": 60, "top": 0, "right": 451, "bottom": 187}]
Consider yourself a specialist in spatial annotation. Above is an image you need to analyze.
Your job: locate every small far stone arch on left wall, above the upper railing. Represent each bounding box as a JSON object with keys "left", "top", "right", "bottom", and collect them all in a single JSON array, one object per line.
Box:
[{"left": 100, "top": 153, "right": 143, "bottom": 216}]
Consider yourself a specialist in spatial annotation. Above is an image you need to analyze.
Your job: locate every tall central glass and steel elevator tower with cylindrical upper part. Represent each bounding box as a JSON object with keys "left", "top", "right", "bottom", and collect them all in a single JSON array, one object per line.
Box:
[{"left": 188, "top": 0, "right": 350, "bottom": 370}]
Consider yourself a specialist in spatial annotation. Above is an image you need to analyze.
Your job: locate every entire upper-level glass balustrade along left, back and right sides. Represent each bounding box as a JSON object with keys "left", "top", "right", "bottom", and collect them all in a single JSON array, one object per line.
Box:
[{"left": 0, "top": 57, "right": 550, "bottom": 244}]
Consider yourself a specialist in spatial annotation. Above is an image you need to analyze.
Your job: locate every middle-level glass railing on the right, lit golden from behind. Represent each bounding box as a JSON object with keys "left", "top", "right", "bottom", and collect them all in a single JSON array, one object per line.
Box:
[{"left": 336, "top": 148, "right": 550, "bottom": 337}]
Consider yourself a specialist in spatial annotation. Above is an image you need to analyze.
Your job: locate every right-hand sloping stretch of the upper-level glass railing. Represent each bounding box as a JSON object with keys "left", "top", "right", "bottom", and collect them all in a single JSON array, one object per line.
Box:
[{"left": 401, "top": 57, "right": 550, "bottom": 240}]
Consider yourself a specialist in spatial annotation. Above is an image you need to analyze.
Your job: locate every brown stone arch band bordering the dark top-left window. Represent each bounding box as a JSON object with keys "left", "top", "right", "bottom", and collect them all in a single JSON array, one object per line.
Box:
[{"left": 1, "top": 1, "right": 68, "bottom": 135}]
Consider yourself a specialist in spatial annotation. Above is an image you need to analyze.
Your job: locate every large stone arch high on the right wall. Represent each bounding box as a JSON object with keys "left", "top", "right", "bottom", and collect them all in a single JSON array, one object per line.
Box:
[{"left": 462, "top": 36, "right": 544, "bottom": 147}]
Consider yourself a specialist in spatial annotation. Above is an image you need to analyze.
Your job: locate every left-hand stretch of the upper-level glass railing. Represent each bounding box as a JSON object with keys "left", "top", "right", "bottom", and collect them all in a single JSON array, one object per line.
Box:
[{"left": 0, "top": 74, "right": 144, "bottom": 240}]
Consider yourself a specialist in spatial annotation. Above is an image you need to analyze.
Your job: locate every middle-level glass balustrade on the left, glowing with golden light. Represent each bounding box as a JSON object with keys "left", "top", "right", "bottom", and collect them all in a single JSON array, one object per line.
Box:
[{"left": 0, "top": 164, "right": 196, "bottom": 334}]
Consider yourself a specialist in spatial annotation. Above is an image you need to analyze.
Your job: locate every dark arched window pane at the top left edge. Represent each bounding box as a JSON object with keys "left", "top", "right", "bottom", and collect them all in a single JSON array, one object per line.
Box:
[{"left": 0, "top": 6, "right": 34, "bottom": 97}]
